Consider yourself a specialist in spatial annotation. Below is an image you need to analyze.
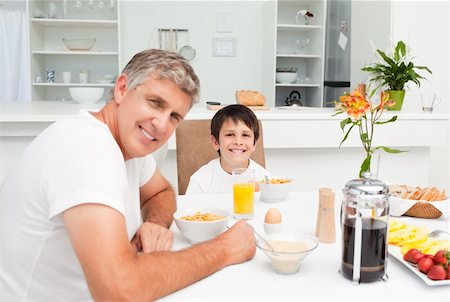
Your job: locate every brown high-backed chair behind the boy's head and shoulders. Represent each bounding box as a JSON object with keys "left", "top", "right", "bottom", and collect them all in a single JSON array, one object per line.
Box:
[{"left": 175, "top": 120, "right": 266, "bottom": 195}]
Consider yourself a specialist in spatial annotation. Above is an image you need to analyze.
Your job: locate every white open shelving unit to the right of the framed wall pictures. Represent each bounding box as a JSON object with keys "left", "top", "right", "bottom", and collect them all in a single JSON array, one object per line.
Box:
[{"left": 274, "top": 0, "right": 326, "bottom": 107}]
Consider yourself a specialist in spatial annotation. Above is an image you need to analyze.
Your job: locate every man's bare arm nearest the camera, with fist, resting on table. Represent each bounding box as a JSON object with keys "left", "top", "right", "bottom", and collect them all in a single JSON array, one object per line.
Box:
[{"left": 63, "top": 203, "right": 256, "bottom": 301}]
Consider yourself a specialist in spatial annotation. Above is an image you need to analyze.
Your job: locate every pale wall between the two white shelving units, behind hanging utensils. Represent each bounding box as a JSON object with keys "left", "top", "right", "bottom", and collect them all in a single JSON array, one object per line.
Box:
[{"left": 120, "top": 1, "right": 268, "bottom": 106}]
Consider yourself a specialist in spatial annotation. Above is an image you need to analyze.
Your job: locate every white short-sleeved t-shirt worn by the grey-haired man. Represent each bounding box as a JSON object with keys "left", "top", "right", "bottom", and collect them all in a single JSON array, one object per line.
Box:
[{"left": 0, "top": 112, "right": 156, "bottom": 301}]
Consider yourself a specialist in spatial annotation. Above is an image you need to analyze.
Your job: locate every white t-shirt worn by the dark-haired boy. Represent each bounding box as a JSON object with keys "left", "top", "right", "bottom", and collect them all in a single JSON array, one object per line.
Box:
[{"left": 186, "top": 158, "right": 270, "bottom": 194}]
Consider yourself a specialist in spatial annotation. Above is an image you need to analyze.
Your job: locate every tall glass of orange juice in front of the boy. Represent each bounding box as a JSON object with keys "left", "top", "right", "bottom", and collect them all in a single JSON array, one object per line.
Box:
[{"left": 233, "top": 168, "right": 255, "bottom": 219}]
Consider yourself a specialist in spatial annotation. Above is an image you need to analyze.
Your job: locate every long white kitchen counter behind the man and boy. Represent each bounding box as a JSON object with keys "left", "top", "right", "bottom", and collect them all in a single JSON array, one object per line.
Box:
[{"left": 0, "top": 101, "right": 450, "bottom": 190}]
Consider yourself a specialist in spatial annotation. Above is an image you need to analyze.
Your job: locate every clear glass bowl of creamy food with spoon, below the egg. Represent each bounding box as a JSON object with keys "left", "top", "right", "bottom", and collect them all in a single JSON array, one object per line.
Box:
[{"left": 256, "top": 233, "right": 319, "bottom": 275}]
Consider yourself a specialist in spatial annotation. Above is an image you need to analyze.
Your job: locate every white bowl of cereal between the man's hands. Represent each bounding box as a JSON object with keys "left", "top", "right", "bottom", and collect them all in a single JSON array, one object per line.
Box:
[{"left": 173, "top": 207, "right": 230, "bottom": 244}]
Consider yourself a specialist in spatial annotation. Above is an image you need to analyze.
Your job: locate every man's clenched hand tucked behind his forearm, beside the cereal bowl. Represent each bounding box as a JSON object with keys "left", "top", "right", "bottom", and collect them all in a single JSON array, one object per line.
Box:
[{"left": 131, "top": 222, "right": 173, "bottom": 253}]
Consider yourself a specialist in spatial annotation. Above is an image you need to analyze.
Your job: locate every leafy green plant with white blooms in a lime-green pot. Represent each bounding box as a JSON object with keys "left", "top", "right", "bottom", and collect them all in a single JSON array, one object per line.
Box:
[{"left": 362, "top": 41, "right": 432, "bottom": 110}]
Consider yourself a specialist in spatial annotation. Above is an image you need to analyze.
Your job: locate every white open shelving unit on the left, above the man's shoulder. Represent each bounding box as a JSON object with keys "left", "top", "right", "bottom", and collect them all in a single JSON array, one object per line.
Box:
[{"left": 27, "top": 0, "right": 119, "bottom": 101}]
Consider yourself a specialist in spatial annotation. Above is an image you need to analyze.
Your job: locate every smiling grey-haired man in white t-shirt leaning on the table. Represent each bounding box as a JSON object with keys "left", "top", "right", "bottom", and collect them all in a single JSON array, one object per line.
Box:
[{"left": 0, "top": 50, "right": 255, "bottom": 301}]
